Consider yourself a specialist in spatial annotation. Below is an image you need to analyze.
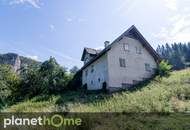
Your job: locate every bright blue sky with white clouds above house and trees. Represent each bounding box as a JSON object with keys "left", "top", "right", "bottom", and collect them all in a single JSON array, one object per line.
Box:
[{"left": 0, "top": 0, "right": 190, "bottom": 68}]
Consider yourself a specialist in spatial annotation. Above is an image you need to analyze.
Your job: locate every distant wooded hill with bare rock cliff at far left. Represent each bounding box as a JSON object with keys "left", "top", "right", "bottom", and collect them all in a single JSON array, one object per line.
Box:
[{"left": 0, "top": 53, "right": 41, "bottom": 71}]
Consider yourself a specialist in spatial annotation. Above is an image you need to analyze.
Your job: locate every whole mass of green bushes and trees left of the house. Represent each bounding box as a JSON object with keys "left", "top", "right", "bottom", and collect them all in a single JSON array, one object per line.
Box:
[{"left": 0, "top": 57, "right": 76, "bottom": 108}]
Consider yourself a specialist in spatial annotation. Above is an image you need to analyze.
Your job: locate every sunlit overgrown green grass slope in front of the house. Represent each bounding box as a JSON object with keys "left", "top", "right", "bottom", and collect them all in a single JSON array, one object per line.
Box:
[{"left": 3, "top": 69, "right": 190, "bottom": 112}]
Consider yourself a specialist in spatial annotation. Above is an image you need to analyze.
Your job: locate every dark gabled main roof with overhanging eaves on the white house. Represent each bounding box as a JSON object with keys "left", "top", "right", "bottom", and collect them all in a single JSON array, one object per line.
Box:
[{"left": 80, "top": 25, "right": 161, "bottom": 71}]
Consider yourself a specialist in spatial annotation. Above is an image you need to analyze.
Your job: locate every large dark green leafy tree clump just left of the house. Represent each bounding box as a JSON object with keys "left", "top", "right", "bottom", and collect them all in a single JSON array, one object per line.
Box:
[{"left": 18, "top": 57, "right": 72, "bottom": 98}]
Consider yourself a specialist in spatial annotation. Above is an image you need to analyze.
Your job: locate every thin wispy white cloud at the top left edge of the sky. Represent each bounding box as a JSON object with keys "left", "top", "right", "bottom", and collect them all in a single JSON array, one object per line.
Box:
[{"left": 9, "top": 0, "right": 41, "bottom": 8}]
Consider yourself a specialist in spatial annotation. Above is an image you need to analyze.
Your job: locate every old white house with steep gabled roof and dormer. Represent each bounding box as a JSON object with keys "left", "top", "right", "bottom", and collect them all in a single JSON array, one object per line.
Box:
[{"left": 81, "top": 25, "right": 160, "bottom": 91}]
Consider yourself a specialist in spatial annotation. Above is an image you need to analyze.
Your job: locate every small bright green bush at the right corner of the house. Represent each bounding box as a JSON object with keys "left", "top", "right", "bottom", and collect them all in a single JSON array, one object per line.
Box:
[{"left": 158, "top": 60, "right": 172, "bottom": 77}]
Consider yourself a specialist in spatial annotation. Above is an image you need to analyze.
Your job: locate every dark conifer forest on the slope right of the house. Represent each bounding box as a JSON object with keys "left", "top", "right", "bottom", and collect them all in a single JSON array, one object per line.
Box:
[{"left": 156, "top": 42, "right": 190, "bottom": 70}]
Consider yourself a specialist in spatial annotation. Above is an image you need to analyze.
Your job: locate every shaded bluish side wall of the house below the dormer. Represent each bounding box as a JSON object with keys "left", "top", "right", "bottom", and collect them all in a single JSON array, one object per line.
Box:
[{"left": 82, "top": 54, "right": 108, "bottom": 90}]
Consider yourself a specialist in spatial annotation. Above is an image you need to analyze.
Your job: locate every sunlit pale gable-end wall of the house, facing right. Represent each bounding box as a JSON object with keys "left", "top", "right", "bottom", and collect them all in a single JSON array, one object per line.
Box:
[{"left": 107, "top": 37, "right": 157, "bottom": 88}]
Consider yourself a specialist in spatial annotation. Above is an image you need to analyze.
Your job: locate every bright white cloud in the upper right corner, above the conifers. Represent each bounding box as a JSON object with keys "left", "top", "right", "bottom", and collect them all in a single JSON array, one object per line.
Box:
[{"left": 153, "top": 0, "right": 190, "bottom": 42}]
